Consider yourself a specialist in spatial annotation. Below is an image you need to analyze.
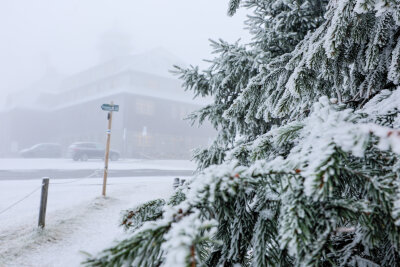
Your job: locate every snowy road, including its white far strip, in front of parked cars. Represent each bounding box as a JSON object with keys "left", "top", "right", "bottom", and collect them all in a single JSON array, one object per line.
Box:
[{"left": 0, "top": 158, "right": 195, "bottom": 180}]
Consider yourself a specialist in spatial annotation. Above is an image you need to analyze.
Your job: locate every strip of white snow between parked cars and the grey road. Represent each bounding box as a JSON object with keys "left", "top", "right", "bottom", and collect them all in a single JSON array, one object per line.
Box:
[{"left": 0, "top": 158, "right": 195, "bottom": 171}]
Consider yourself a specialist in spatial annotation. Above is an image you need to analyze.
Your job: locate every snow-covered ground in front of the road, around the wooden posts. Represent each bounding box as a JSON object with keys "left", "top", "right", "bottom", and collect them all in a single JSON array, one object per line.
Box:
[{"left": 0, "top": 177, "right": 180, "bottom": 267}]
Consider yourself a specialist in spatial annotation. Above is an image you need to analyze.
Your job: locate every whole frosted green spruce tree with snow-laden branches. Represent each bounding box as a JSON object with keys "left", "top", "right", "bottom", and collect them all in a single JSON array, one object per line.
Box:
[{"left": 85, "top": 0, "right": 400, "bottom": 266}]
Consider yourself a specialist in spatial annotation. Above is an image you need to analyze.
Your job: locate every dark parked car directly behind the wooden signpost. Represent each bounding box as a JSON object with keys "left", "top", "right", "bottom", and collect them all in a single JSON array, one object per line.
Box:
[{"left": 68, "top": 142, "right": 119, "bottom": 161}]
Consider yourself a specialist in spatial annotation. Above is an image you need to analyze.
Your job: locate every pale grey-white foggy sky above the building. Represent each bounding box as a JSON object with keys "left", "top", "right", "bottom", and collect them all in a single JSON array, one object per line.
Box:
[{"left": 0, "top": 0, "right": 250, "bottom": 103}]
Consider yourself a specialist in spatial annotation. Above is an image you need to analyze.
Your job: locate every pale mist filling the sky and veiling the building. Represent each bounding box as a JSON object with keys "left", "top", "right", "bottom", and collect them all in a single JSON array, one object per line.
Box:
[{"left": 0, "top": 0, "right": 250, "bottom": 158}]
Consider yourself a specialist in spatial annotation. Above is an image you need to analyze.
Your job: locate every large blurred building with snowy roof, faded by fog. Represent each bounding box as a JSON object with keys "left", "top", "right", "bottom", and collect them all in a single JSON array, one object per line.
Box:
[{"left": 0, "top": 49, "right": 214, "bottom": 158}]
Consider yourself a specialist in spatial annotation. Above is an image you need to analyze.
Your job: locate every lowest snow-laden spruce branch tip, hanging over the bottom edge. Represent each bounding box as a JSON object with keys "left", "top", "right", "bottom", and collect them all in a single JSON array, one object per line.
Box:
[{"left": 85, "top": 195, "right": 219, "bottom": 266}]
